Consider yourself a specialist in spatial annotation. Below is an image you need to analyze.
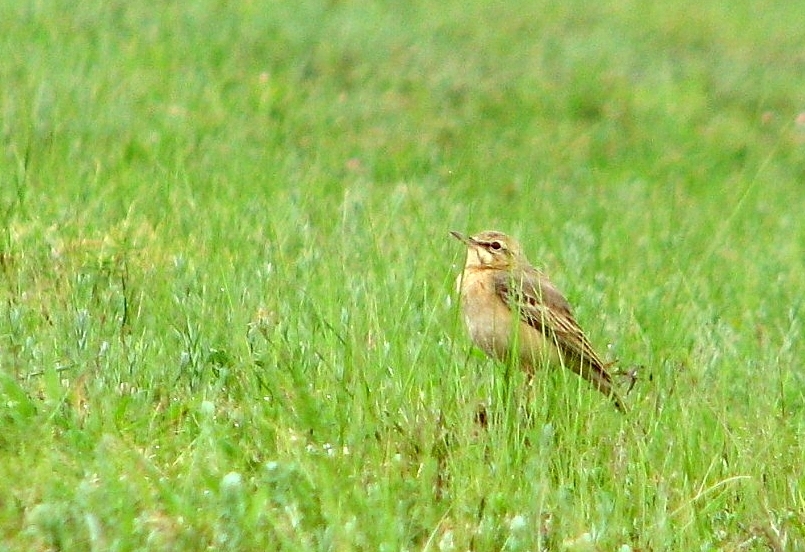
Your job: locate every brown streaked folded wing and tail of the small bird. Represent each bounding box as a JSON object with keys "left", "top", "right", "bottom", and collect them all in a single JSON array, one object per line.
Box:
[{"left": 494, "top": 269, "right": 623, "bottom": 410}]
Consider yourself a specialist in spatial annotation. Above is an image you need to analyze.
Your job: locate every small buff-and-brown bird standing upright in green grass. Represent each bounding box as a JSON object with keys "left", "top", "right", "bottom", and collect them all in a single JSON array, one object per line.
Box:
[{"left": 451, "top": 227, "right": 624, "bottom": 410}]
